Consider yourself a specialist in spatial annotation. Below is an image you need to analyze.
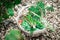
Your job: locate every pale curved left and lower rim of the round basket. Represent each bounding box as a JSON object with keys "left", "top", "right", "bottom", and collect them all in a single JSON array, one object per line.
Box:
[{"left": 14, "top": 5, "right": 46, "bottom": 37}]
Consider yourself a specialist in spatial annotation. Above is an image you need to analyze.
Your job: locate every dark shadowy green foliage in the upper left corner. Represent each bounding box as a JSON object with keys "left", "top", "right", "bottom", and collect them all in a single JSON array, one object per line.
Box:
[{"left": 0, "top": 0, "right": 21, "bottom": 23}]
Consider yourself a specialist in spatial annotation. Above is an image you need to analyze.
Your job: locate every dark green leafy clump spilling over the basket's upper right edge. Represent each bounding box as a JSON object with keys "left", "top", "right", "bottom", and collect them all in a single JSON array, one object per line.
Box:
[{"left": 29, "top": 1, "right": 45, "bottom": 16}]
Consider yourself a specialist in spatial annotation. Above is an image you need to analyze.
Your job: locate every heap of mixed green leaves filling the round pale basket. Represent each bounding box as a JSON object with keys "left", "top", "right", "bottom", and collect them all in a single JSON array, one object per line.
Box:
[{"left": 22, "top": 1, "right": 54, "bottom": 33}]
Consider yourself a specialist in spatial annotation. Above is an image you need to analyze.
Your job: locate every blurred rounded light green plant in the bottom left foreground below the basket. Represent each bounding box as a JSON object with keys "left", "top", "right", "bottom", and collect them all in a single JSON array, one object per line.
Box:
[{"left": 5, "top": 29, "right": 24, "bottom": 40}]
